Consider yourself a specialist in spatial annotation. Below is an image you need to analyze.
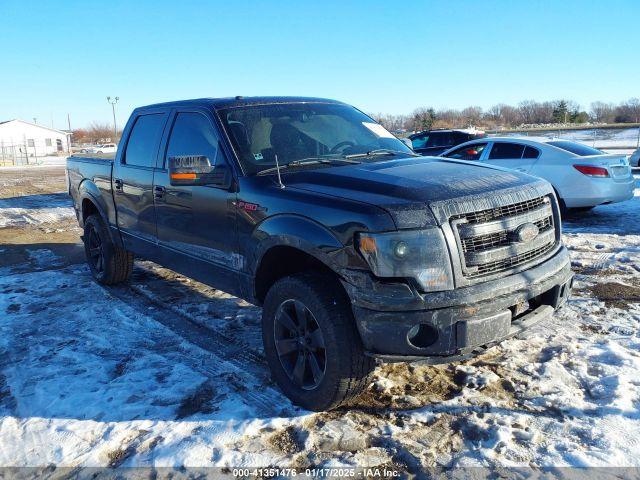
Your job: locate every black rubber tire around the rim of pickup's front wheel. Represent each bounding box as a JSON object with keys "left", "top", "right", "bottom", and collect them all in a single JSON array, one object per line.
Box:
[{"left": 262, "top": 273, "right": 375, "bottom": 411}]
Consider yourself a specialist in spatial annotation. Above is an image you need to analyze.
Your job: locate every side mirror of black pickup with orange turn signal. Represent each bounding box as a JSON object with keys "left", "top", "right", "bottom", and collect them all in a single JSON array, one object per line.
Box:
[{"left": 169, "top": 155, "right": 231, "bottom": 188}]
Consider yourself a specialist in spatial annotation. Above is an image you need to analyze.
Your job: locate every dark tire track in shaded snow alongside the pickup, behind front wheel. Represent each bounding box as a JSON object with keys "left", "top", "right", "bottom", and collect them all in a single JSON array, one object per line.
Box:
[{"left": 105, "top": 285, "right": 293, "bottom": 416}]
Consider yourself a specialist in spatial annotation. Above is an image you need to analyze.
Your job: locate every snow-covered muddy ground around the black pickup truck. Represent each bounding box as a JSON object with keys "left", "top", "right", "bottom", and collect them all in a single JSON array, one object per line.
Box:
[{"left": 0, "top": 168, "right": 640, "bottom": 471}]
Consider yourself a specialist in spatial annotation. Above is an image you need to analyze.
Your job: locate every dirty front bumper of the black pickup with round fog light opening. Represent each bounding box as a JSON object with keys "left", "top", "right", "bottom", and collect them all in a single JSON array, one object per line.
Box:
[{"left": 343, "top": 247, "right": 573, "bottom": 364}]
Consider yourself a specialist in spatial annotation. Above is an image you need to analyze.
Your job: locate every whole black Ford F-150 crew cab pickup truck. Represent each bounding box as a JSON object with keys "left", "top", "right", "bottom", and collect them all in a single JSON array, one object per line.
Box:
[{"left": 67, "top": 97, "right": 573, "bottom": 410}]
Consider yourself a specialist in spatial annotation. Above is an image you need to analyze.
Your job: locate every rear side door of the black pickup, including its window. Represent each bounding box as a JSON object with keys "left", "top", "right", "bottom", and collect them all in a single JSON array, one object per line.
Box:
[{"left": 112, "top": 110, "right": 168, "bottom": 256}]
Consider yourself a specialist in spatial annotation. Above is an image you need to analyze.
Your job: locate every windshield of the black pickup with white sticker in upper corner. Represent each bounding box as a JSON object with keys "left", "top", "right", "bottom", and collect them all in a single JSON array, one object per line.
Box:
[{"left": 219, "top": 103, "right": 414, "bottom": 175}]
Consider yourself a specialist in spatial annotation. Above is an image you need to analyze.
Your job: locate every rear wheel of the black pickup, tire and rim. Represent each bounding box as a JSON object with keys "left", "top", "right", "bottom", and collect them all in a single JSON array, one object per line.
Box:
[{"left": 82, "top": 215, "right": 133, "bottom": 285}]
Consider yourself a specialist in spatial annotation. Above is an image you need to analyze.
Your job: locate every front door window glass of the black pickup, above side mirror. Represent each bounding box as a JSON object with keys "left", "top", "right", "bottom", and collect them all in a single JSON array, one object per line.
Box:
[{"left": 167, "top": 113, "right": 219, "bottom": 166}]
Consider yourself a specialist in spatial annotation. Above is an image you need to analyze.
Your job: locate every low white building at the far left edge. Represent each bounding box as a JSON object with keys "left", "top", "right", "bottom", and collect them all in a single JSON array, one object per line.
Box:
[{"left": 0, "top": 120, "right": 71, "bottom": 158}]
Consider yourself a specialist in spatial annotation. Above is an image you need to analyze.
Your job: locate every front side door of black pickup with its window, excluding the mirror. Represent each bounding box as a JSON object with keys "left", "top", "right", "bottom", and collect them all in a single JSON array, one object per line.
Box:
[{"left": 154, "top": 110, "right": 240, "bottom": 293}]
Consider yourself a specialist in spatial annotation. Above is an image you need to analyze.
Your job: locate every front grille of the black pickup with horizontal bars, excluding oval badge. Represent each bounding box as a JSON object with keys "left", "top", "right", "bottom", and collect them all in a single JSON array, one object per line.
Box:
[{"left": 451, "top": 196, "right": 558, "bottom": 278}]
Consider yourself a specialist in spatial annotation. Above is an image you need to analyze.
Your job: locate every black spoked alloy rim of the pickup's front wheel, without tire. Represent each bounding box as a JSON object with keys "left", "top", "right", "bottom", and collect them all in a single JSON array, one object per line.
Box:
[{"left": 273, "top": 299, "right": 327, "bottom": 390}]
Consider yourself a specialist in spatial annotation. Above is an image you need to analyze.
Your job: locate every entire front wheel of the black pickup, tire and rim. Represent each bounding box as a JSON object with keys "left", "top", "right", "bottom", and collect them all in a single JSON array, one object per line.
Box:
[{"left": 262, "top": 273, "right": 375, "bottom": 411}]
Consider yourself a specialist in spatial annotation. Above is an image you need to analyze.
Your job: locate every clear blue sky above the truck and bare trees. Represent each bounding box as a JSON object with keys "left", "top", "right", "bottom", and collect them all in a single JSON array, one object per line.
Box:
[{"left": 0, "top": 0, "right": 640, "bottom": 128}]
